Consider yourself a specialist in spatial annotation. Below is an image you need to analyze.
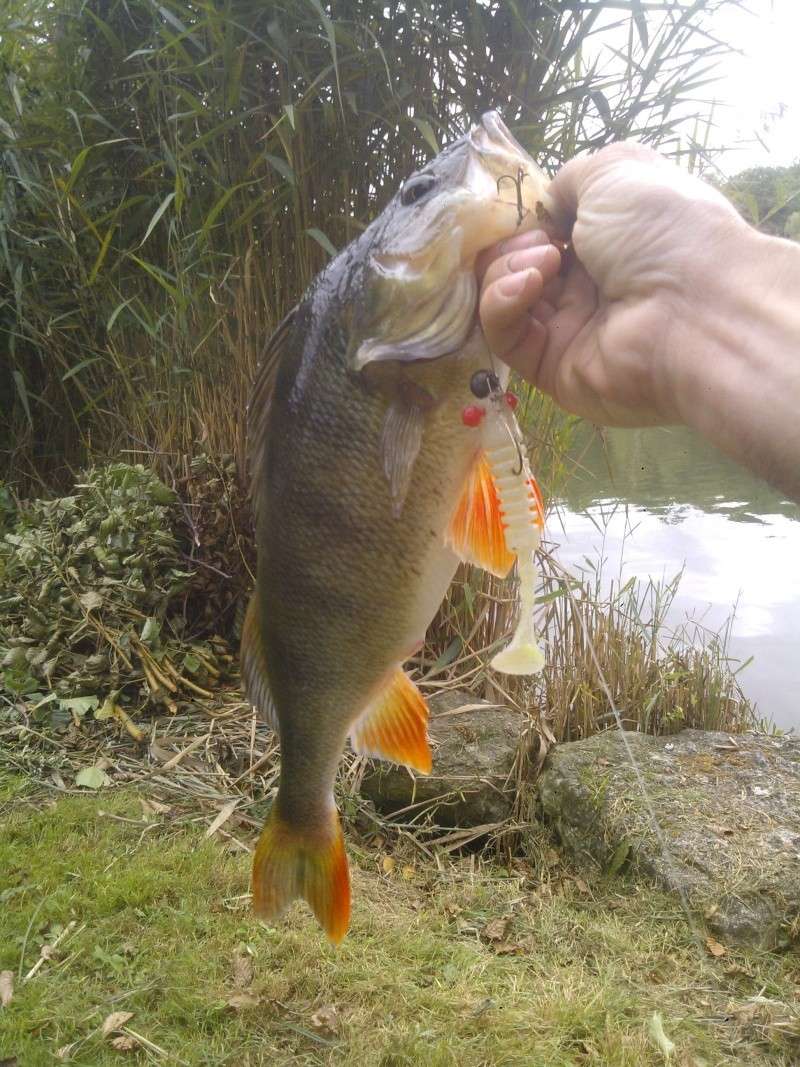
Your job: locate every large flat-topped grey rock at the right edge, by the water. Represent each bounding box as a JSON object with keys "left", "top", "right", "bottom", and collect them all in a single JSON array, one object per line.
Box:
[{"left": 539, "top": 730, "right": 800, "bottom": 949}]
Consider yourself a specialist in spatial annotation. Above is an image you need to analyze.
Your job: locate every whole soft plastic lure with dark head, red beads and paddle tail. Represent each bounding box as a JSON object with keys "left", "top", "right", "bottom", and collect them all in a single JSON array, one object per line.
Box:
[{"left": 462, "top": 371, "right": 544, "bottom": 674}]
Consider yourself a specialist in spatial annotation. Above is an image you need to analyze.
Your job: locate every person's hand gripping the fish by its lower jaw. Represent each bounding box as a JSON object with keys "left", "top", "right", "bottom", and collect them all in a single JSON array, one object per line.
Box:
[{"left": 478, "top": 144, "right": 753, "bottom": 426}]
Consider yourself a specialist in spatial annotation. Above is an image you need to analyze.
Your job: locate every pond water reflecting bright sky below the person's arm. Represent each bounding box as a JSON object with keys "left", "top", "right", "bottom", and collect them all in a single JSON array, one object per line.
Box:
[{"left": 549, "top": 427, "right": 800, "bottom": 732}]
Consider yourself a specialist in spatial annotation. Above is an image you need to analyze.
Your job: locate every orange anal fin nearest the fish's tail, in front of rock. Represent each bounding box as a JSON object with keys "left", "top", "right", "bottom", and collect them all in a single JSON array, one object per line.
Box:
[{"left": 350, "top": 667, "right": 432, "bottom": 775}]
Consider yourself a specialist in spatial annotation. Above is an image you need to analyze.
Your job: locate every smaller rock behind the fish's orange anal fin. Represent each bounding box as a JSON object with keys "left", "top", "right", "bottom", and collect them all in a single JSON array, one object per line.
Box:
[{"left": 362, "top": 689, "right": 527, "bottom": 827}]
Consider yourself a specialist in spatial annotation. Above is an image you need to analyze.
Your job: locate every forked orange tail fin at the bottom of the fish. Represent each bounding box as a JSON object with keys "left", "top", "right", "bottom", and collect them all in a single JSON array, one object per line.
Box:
[{"left": 253, "top": 800, "right": 350, "bottom": 944}]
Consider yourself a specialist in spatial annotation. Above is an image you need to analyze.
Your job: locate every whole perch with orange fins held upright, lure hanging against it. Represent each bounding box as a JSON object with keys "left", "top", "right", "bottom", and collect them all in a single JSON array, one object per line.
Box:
[{"left": 241, "top": 112, "right": 551, "bottom": 942}]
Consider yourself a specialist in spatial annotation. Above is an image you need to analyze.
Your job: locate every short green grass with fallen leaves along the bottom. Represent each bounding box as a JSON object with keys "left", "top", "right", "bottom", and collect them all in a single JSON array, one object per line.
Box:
[{"left": 0, "top": 778, "right": 800, "bottom": 1067}]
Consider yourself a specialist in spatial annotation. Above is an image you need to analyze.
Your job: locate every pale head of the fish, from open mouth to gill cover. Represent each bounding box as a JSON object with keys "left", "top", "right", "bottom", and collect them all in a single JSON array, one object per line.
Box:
[{"left": 348, "top": 112, "right": 548, "bottom": 371}]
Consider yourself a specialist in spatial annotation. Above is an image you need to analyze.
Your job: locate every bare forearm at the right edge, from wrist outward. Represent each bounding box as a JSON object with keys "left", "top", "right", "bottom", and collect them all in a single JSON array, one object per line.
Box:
[{"left": 674, "top": 230, "right": 800, "bottom": 501}]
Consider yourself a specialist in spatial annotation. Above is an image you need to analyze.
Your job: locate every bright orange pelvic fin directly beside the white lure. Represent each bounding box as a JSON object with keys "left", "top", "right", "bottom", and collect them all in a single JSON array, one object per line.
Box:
[{"left": 445, "top": 451, "right": 516, "bottom": 578}]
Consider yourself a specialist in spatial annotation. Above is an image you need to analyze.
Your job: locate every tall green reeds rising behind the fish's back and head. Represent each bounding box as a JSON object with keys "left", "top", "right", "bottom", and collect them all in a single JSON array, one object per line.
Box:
[{"left": 0, "top": 0, "right": 724, "bottom": 485}]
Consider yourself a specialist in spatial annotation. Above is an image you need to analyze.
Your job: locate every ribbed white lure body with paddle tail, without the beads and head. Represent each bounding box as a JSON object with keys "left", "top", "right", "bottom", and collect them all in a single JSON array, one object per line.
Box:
[{"left": 481, "top": 394, "right": 544, "bottom": 674}]
